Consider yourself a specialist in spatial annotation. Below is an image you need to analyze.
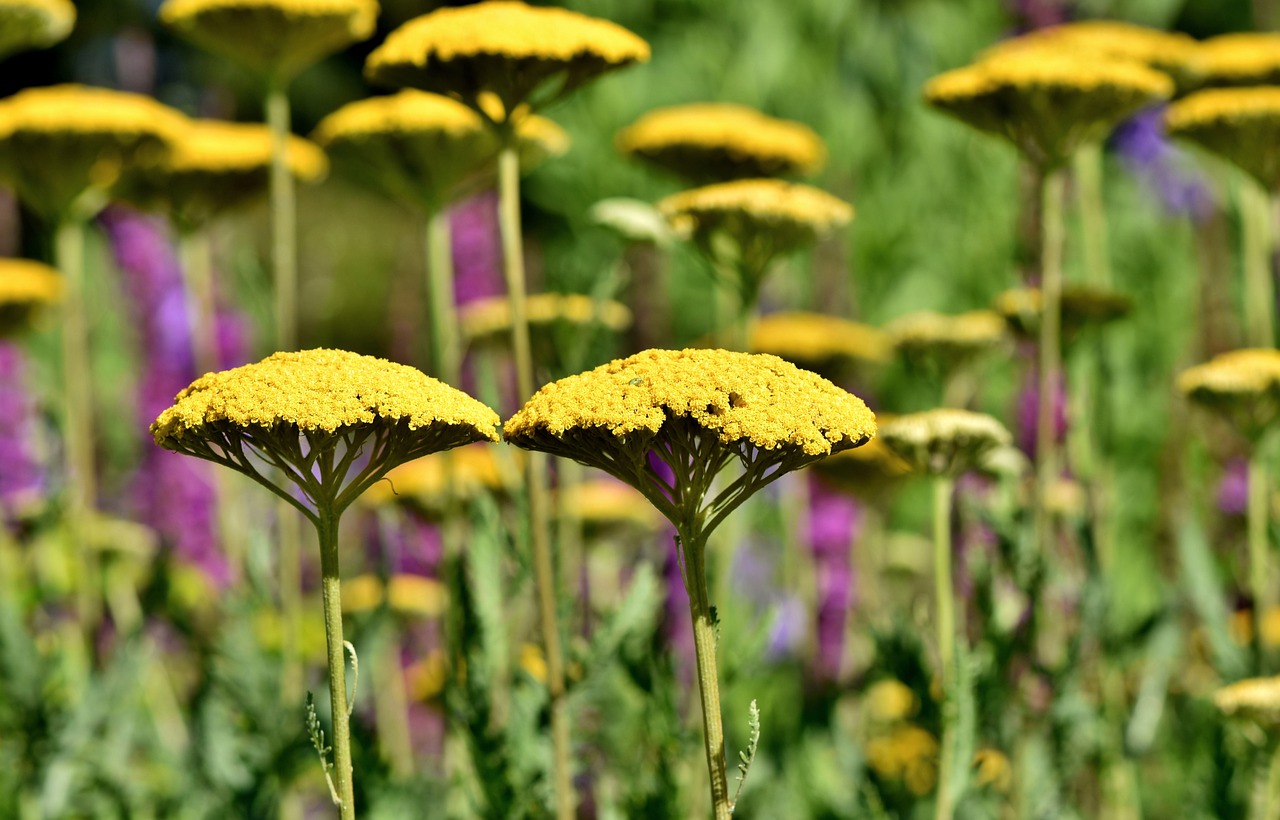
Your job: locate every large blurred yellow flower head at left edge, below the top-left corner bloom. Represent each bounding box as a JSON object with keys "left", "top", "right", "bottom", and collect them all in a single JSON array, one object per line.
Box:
[{"left": 0, "top": 86, "right": 187, "bottom": 217}]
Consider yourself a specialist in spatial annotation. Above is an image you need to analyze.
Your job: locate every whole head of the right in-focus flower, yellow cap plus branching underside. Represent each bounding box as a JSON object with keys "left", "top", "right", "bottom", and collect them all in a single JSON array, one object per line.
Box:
[{"left": 503, "top": 349, "right": 876, "bottom": 539}]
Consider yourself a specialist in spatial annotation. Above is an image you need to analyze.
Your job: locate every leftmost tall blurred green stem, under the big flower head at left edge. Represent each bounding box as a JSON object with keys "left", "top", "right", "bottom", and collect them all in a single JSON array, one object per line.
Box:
[{"left": 55, "top": 215, "right": 102, "bottom": 631}]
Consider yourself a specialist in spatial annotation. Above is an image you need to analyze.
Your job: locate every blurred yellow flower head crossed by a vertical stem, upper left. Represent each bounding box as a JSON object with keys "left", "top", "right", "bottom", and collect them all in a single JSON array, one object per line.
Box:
[{"left": 115, "top": 120, "right": 329, "bottom": 229}]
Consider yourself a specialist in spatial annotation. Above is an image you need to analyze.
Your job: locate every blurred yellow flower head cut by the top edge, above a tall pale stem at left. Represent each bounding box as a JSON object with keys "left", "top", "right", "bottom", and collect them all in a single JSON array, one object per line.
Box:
[{"left": 160, "top": 0, "right": 378, "bottom": 81}]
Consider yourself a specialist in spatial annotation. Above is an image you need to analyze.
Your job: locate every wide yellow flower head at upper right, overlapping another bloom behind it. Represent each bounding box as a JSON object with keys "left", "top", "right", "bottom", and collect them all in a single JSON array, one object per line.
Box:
[{"left": 924, "top": 49, "right": 1174, "bottom": 168}]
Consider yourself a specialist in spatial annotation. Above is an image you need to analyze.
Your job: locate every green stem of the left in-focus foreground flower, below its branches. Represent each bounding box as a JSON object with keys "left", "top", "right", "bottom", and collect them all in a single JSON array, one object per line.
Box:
[{"left": 317, "top": 509, "right": 356, "bottom": 820}]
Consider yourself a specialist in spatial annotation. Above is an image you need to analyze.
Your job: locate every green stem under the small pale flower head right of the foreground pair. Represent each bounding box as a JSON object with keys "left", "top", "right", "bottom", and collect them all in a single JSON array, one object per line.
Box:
[{"left": 933, "top": 476, "right": 956, "bottom": 820}]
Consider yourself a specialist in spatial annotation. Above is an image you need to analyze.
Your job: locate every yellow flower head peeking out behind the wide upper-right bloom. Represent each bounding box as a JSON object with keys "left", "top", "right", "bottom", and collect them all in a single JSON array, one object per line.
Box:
[{"left": 982, "top": 20, "right": 1199, "bottom": 84}]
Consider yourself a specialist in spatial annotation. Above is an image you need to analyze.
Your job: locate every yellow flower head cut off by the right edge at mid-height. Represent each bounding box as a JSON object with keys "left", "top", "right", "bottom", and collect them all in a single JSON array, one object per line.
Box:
[{"left": 1178, "top": 348, "right": 1280, "bottom": 441}]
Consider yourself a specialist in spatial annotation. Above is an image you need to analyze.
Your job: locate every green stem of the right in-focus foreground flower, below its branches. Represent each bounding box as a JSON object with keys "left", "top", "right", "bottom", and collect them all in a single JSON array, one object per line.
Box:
[{"left": 681, "top": 535, "right": 733, "bottom": 820}]
